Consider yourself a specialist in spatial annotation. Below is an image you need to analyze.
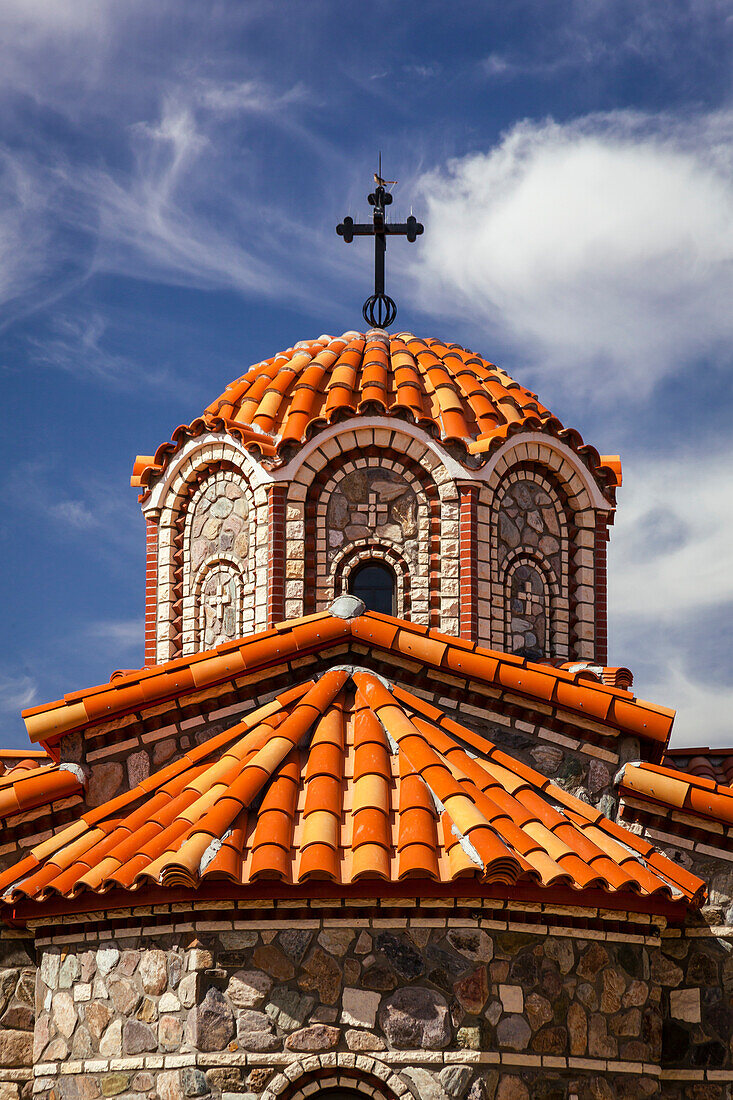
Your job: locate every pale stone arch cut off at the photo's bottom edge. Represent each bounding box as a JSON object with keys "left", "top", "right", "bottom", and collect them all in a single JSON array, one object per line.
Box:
[{"left": 261, "top": 1054, "right": 405, "bottom": 1100}]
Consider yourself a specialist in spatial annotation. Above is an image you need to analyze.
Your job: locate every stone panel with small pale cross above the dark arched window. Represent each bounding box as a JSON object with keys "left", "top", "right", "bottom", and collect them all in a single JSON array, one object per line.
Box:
[{"left": 326, "top": 468, "right": 417, "bottom": 561}]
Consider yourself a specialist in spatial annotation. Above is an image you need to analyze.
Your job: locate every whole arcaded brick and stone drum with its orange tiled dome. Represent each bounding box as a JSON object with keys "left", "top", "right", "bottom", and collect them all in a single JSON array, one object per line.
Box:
[{"left": 133, "top": 330, "right": 619, "bottom": 663}]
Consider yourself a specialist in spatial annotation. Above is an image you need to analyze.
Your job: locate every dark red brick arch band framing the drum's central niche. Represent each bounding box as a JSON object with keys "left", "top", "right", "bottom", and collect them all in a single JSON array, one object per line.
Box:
[{"left": 304, "top": 443, "right": 441, "bottom": 626}]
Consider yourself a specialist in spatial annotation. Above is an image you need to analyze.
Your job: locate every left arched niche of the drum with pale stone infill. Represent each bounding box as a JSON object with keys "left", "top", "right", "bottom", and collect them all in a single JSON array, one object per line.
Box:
[{"left": 146, "top": 443, "right": 267, "bottom": 663}]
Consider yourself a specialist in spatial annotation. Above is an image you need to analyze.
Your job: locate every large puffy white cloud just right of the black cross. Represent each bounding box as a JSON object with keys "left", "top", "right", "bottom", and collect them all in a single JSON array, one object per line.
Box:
[{"left": 414, "top": 112, "right": 733, "bottom": 396}]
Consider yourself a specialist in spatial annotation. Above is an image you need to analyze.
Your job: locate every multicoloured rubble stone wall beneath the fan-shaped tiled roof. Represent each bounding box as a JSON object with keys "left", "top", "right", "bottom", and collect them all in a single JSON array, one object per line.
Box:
[{"left": 24, "top": 906, "right": 733, "bottom": 1100}]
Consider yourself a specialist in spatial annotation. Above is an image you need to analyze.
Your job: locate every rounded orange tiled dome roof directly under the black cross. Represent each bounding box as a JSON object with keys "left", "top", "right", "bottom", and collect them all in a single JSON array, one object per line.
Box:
[{"left": 131, "top": 330, "right": 621, "bottom": 498}]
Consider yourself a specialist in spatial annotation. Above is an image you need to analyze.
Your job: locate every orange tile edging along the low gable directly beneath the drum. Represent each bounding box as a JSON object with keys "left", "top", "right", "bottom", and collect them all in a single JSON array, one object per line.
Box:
[{"left": 19, "top": 612, "right": 674, "bottom": 752}]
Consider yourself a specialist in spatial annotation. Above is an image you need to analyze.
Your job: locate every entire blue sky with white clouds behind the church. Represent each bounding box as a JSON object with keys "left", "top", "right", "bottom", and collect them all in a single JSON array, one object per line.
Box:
[{"left": 0, "top": 0, "right": 733, "bottom": 746}]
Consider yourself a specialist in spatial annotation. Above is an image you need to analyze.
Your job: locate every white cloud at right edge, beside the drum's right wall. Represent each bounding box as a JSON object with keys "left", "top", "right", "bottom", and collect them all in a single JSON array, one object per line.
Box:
[{"left": 609, "top": 447, "right": 733, "bottom": 746}]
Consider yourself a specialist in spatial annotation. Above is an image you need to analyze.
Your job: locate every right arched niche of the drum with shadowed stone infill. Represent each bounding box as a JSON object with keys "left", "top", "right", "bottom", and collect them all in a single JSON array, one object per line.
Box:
[{"left": 491, "top": 462, "right": 573, "bottom": 658}]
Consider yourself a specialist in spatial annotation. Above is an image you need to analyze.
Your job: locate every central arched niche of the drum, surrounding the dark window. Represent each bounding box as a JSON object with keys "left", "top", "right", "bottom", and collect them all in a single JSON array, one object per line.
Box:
[{"left": 285, "top": 429, "right": 459, "bottom": 634}]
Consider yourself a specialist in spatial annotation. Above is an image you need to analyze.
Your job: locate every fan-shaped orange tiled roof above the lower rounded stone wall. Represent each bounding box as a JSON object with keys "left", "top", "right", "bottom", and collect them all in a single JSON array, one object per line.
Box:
[{"left": 0, "top": 667, "right": 704, "bottom": 908}]
